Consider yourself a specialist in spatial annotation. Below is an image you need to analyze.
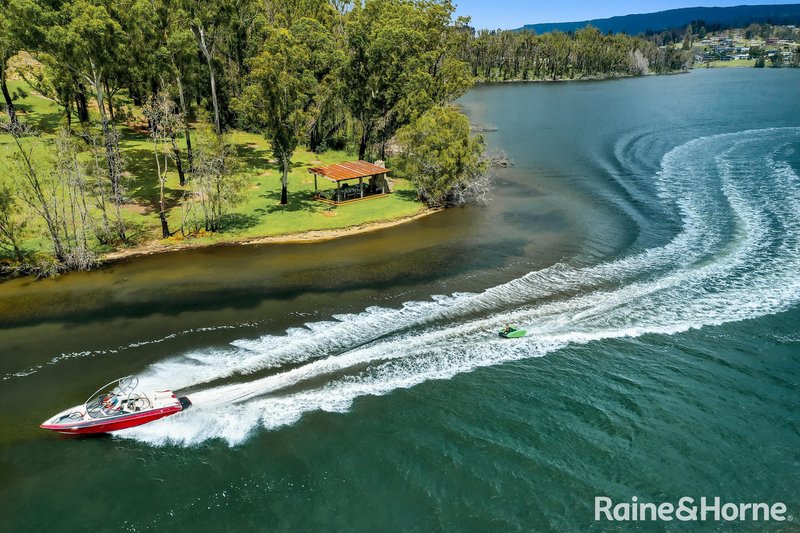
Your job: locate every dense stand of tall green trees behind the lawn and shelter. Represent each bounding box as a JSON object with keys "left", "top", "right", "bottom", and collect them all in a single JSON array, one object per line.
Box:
[{"left": 0, "top": 0, "right": 471, "bottom": 161}]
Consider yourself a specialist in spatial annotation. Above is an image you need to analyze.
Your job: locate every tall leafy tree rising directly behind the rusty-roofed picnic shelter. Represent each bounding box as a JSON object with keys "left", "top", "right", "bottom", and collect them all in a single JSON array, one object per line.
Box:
[{"left": 343, "top": 0, "right": 472, "bottom": 159}]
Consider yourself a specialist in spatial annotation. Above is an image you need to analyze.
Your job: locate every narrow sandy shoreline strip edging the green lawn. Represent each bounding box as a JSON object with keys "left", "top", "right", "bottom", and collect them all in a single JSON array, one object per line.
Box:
[{"left": 100, "top": 208, "right": 442, "bottom": 265}]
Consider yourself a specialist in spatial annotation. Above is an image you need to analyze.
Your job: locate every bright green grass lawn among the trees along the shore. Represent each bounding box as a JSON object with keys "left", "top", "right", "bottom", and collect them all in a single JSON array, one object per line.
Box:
[{"left": 0, "top": 81, "right": 424, "bottom": 260}]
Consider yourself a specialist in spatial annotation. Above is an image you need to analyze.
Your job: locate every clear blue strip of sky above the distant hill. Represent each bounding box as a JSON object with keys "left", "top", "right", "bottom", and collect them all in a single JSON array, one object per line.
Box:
[{"left": 453, "top": 0, "right": 800, "bottom": 29}]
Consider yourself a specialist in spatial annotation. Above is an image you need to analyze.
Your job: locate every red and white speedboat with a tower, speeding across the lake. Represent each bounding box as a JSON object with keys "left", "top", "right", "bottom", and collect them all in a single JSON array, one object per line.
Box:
[{"left": 40, "top": 376, "right": 192, "bottom": 435}]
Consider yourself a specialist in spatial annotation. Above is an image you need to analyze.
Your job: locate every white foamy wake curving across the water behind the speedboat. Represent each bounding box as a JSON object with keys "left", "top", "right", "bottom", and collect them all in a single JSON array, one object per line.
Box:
[{"left": 121, "top": 128, "right": 800, "bottom": 445}]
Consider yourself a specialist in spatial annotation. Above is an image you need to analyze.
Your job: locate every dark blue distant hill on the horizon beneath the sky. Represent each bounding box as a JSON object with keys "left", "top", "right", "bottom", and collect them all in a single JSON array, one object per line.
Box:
[{"left": 519, "top": 4, "right": 800, "bottom": 35}]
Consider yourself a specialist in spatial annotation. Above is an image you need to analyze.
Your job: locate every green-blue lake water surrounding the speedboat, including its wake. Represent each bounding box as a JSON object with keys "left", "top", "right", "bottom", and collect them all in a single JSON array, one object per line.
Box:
[{"left": 0, "top": 69, "right": 800, "bottom": 531}]
